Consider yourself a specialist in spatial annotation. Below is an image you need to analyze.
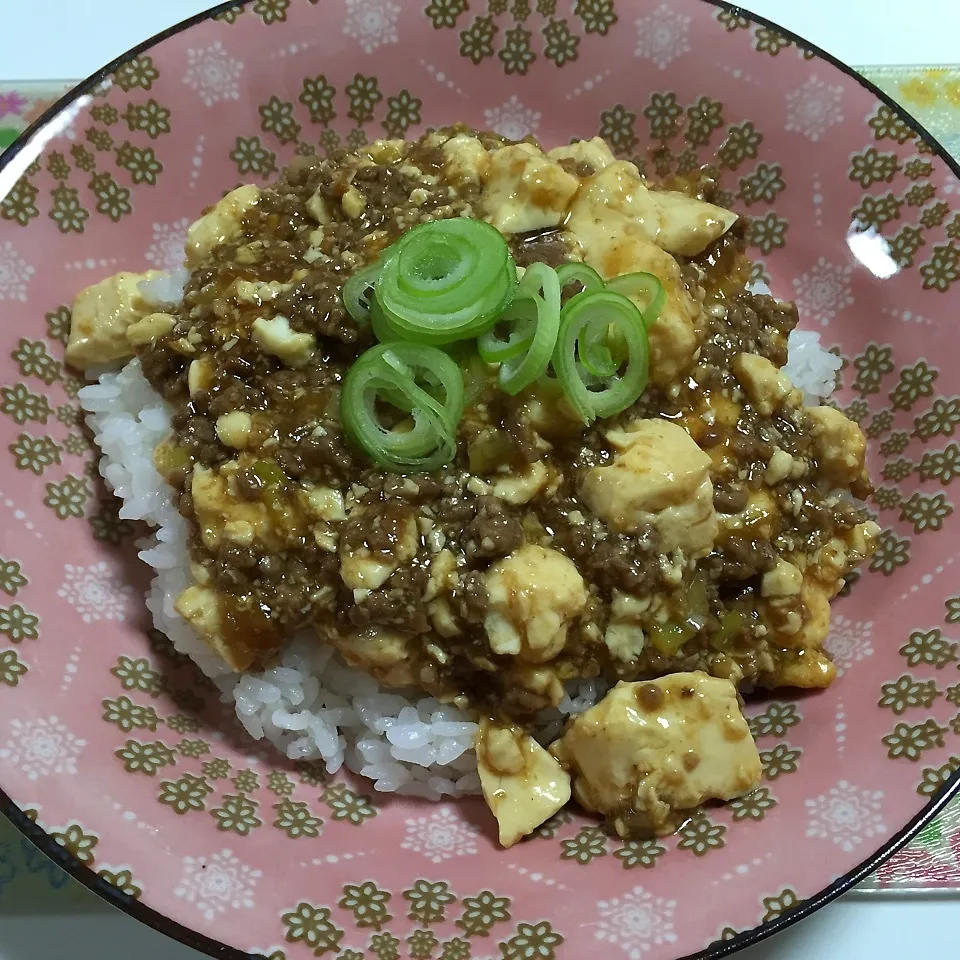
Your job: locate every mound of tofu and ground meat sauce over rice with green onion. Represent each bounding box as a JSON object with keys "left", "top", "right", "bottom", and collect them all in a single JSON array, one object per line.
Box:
[{"left": 67, "top": 128, "right": 879, "bottom": 845}]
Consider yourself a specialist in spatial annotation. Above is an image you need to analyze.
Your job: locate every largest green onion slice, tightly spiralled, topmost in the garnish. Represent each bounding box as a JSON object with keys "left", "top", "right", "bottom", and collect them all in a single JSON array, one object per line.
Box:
[{"left": 375, "top": 217, "right": 517, "bottom": 344}]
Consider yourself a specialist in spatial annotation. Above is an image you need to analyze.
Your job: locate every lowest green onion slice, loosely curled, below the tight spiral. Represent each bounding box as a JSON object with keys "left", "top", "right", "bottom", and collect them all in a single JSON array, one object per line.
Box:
[{"left": 340, "top": 342, "right": 464, "bottom": 473}]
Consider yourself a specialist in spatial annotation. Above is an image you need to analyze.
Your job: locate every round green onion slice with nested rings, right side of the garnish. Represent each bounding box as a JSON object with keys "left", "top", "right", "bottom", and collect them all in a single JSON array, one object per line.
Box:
[{"left": 553, "top": 290, "right": 650, "bottom": 423}]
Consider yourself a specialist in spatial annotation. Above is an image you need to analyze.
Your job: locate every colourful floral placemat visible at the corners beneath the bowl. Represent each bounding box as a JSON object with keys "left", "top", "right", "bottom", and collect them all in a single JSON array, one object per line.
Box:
[{"left": 0, "top": 66, "right": 960, "bottom": 919}]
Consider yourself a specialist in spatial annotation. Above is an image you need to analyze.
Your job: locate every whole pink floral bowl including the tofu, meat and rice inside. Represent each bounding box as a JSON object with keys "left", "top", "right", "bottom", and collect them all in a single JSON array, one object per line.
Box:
[{"left": 0, "top": 0, "right": 960, "bottom": 960}]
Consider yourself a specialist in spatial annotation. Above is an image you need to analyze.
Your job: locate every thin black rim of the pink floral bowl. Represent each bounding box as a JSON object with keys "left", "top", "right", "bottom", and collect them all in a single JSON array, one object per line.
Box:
[{"left": 0, "top": 0, "right": 960, "bottom": 960}]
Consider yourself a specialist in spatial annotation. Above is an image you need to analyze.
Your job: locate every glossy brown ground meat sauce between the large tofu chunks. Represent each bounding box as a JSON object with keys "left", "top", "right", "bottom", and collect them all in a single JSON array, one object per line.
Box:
[{"left": 141, "top": 130, "right": 868, "bottom": 717}]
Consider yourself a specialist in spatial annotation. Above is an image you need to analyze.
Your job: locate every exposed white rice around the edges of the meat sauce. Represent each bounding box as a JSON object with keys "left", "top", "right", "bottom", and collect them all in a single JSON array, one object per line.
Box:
[{"left": 80, "top": 270, "right": 840, "bottom": 799}]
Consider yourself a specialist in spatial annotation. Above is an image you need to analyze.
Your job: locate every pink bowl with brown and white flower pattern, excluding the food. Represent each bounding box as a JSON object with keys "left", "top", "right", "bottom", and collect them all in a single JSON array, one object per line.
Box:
[{"left": 0, "top": 0, "right": 960, "bottom": 960}]
